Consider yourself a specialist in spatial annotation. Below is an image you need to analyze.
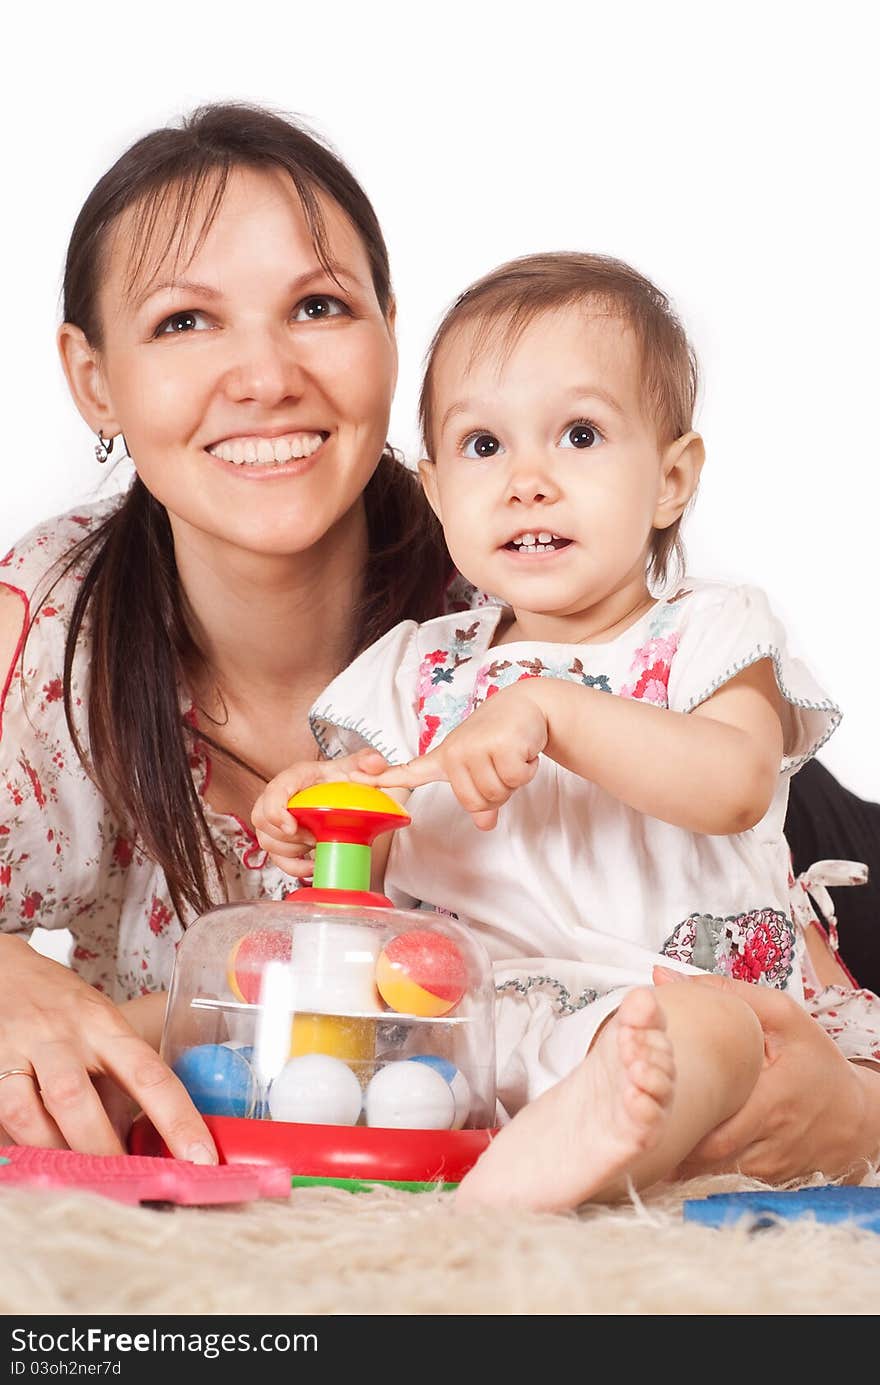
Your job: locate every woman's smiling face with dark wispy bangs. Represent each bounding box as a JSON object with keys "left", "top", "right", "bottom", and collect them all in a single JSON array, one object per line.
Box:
[{"left": 76, "top": 168, "right": 396, "bottom": 555}]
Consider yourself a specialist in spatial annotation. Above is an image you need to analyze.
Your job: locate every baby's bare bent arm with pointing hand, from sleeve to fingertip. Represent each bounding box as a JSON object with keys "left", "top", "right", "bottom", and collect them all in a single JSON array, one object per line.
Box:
[{"left": 373, "top": 659, "right": 783, "bottom": 835}]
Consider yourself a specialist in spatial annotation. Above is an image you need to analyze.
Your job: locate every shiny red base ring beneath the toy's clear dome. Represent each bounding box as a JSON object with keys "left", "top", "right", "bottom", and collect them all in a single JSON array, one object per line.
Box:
[{"left": 129, "top": 1115, "right": 496, "bottom": 1183}]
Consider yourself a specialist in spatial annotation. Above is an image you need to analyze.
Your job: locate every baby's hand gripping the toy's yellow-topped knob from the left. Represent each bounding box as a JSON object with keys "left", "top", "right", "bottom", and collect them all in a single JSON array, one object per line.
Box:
[{"left": 251, "top": 749, "right": 388, "bottom": 879}]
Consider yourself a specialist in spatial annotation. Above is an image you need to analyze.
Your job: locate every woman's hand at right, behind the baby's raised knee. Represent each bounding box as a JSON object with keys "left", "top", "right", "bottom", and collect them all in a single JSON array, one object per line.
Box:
[{"left": 654, "top": 967, "right": 880, "bottom": 1183}]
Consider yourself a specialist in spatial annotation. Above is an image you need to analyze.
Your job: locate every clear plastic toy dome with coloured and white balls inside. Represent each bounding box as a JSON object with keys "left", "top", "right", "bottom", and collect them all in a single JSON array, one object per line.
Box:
[{"left": 162, "top": 897, "right": 495, "bottom": 1132}]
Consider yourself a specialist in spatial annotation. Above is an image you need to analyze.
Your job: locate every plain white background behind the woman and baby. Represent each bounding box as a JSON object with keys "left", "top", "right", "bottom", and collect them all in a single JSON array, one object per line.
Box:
[{"left": 0, "top": 0, "right": 880, "bottom": 798}]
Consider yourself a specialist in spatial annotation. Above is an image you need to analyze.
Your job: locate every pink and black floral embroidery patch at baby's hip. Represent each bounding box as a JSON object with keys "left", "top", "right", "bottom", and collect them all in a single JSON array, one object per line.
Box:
[{"left": 661, "top": 909, "right": 794, "bottom": 990}]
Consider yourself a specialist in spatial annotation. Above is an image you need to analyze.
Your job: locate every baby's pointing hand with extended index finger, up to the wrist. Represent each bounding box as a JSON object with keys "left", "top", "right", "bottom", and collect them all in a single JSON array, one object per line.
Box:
[{"left": 358, "top": 679, "right": 549, "bottom": 831}]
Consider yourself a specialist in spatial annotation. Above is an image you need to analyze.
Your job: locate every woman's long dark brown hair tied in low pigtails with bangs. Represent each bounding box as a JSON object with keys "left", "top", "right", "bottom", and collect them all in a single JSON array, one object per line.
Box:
[{"left": 49, "top": 104, "right": 452, "bottom": 915}]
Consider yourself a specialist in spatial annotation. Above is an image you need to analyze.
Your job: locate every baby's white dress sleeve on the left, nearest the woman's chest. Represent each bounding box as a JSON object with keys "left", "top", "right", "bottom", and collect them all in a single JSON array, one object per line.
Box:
[{"left": 309, "top": 620, "right": 420, "bottom": 765}]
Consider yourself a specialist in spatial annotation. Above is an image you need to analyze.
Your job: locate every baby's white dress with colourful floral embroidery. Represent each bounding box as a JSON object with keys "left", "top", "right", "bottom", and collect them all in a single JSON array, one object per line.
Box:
[{"left": 310, "top": 580, "right": 859, "bottom": 1119}]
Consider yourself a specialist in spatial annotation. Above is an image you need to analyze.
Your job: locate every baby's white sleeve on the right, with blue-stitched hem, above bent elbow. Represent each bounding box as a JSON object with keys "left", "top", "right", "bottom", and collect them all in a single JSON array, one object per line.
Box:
[{"left": 668, "top": 583, "right": 841, "bottom": 771}]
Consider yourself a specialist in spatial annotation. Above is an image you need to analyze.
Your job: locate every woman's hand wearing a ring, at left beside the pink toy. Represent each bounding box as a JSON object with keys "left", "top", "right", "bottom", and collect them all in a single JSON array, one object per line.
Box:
[{"left": 0, "top": 936, "right": 216, "bottom": 1163}]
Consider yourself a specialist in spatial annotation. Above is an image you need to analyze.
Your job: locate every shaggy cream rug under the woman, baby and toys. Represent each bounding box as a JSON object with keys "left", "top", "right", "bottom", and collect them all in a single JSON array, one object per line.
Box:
[{"left": 0, "top": 1173, "right": 880, "bottom": 1314}]
